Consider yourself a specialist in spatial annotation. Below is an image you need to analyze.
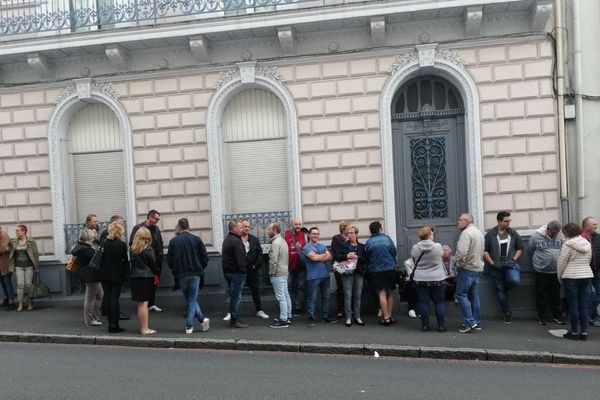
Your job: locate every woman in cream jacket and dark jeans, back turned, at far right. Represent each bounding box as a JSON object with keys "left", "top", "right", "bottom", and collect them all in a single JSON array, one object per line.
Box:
[{"left": 557, "top": 223, "right": 594, "bottom": 340}]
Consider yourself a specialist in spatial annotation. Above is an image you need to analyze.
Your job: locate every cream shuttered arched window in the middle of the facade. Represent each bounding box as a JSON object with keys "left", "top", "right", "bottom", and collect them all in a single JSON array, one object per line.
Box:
[{"left": 221, "top": 89, "right": 290, "bottom": 214}]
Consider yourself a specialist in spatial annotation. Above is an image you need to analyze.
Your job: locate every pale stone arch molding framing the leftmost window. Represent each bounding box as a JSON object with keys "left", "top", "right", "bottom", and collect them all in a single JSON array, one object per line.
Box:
[{"left": 48, "top": 79, "right": 137, "bottom": 262}]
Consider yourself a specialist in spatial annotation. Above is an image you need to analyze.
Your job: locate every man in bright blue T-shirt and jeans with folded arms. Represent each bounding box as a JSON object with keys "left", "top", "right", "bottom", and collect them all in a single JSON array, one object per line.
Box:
[{"left": 304, "top": 227, "right": 337, "bottom": 327}]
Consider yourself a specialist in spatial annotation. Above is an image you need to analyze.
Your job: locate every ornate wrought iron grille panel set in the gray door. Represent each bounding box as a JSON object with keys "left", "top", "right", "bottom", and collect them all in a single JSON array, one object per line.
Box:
[{"left": 410, "top": 137, "right": 448, "bottom": 219}]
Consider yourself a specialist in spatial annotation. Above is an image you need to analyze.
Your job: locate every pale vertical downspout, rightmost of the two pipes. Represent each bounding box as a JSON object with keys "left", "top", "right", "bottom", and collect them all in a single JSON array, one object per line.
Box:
[{"left": 572, "top": 0, "right": 587, "bottom": 221}]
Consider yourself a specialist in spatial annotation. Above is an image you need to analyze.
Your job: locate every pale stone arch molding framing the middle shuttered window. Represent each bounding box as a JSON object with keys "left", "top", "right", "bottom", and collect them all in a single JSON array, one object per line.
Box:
[{"left": 206, "top": 62, "right": 302, "bottom": 249}]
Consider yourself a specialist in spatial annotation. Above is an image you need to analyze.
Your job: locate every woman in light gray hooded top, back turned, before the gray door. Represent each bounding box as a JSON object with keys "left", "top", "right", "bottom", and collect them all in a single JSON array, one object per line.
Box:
[{"left": 410, "top": 226, "right": 446, "bottom": 332}]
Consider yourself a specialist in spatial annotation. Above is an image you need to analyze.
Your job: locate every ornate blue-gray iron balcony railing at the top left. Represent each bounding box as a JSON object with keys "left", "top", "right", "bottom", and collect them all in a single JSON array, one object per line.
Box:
[{"left": 0, "top": 0, "right": 319, "bottom": 35}]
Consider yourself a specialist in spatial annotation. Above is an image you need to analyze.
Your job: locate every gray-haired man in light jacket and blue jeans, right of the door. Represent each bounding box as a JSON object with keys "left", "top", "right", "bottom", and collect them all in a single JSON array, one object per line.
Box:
[{"left": 455, "top": 214, "right": 484, "bottom": 333}]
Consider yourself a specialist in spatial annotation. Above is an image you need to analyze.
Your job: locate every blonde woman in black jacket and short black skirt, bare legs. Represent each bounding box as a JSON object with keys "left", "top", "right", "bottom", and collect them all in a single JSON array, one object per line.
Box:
[{"left": 130, "top": 227, "right": 158, "bottom": 335}]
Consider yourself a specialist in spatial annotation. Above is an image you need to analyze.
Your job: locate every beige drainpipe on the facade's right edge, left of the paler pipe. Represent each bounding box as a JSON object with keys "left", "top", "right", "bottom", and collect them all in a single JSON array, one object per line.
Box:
[{"left": 554, "top": 0, "right": 569, "bottom": 224}]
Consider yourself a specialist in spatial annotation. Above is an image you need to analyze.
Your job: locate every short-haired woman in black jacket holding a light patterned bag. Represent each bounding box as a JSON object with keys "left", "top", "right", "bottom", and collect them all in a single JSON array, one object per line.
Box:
[{"left": 334, "top": 226, "right": 367, "bottom": 327}]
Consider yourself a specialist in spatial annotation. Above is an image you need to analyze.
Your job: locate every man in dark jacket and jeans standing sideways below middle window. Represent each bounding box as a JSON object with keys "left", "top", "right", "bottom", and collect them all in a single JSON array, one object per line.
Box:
[{"left": 221, "top": 219, "right": 248, "bottom": 328}]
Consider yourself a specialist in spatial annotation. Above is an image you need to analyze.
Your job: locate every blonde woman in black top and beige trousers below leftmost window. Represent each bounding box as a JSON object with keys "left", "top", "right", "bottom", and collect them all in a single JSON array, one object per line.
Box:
[{"left": 71, "top": 228, "right": 104, "bottom": 326}]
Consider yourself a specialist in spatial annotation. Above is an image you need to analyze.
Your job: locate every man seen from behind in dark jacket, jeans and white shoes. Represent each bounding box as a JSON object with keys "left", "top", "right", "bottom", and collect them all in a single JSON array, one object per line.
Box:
[{"left": 167, "top": 218, "right": 210, "bottom": 335}]
